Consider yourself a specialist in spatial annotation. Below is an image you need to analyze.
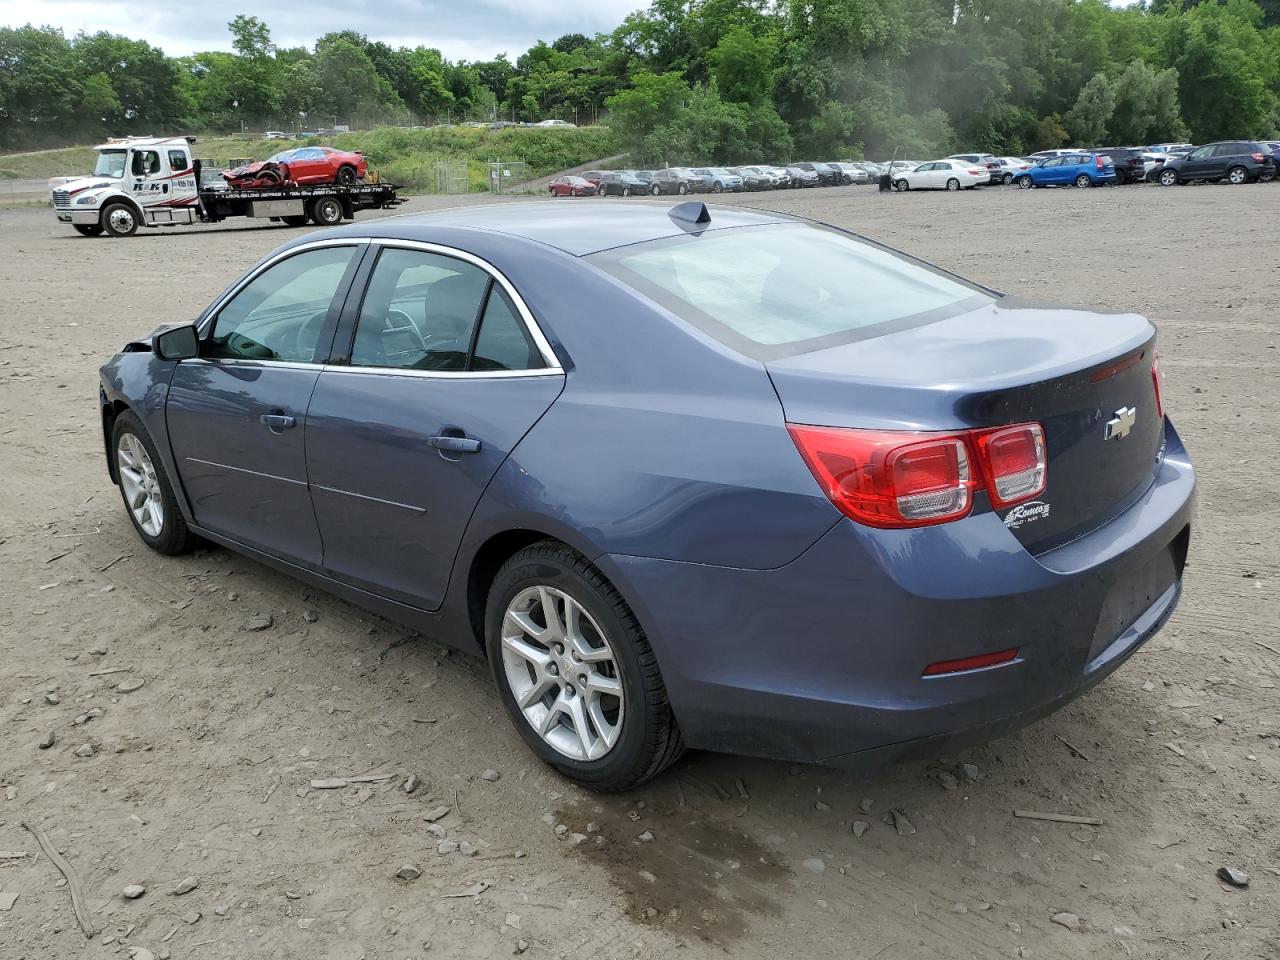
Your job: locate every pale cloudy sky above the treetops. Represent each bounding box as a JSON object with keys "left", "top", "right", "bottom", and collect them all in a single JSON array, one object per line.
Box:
[{"left": 0, "top": 0, "right": 648, "bottom": 60}]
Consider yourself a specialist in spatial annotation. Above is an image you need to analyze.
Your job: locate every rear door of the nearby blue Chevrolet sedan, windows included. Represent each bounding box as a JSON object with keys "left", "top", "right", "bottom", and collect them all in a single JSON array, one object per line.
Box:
[{"left": 306, "top": 242, "right": 564, "bottom": 609}]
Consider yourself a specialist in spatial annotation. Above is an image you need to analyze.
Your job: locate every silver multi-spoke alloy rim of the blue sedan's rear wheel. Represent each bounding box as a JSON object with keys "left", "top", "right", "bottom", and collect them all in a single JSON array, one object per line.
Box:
[{"left": 502, "top": 586, "right": 625, "bottom": 762}]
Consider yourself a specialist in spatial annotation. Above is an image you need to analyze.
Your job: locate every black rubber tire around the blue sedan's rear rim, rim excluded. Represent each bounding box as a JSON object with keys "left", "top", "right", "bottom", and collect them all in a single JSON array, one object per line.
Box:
[{"left": 485, "top": 540, "right": 685, "bottom": 792}]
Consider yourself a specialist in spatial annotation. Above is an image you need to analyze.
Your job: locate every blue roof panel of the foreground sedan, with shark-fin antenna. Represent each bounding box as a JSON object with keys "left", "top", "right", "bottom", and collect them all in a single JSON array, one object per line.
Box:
[{"left": 325, "top": 200, "right": 796, "bottom": 256}]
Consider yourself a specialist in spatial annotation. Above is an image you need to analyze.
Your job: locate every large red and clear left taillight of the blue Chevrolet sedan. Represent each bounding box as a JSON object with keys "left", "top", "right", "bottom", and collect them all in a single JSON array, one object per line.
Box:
[{"left": 787, "top": 424, "right": 1047, "bottom": 529}]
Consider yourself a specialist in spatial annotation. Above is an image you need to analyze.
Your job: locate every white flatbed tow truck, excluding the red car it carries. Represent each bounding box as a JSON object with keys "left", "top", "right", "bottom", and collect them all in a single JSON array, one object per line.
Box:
[{"left": 51, "top": 137, "right": 404, "bottom": 237}]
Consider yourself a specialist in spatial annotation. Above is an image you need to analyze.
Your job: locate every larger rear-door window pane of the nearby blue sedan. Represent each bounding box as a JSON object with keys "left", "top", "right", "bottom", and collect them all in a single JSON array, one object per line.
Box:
[{"left": 351, "top": 247, "right": 489, "bottom": 371}]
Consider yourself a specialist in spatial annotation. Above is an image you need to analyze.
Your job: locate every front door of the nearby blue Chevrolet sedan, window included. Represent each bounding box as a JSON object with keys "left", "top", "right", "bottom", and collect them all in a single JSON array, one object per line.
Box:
[{"left": 165, "top": 242, "right": 366, "bottom": 568}]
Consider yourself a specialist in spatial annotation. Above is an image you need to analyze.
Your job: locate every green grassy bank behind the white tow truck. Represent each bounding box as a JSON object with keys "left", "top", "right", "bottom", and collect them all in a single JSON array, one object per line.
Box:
[{"left": 0, "top": 127, "right": 618, "bottom": 193}]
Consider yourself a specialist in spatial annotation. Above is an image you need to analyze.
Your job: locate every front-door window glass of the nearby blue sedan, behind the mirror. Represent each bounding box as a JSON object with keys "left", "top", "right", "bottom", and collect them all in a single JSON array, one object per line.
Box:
[{"left": 208, "top": 247, "right": 356, "bottom": 364}]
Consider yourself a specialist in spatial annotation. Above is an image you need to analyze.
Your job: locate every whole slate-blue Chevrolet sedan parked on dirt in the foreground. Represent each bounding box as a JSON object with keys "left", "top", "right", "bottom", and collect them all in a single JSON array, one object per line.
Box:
[{"left": 100, "top": 202, "right": 1196, "bottom": 790}]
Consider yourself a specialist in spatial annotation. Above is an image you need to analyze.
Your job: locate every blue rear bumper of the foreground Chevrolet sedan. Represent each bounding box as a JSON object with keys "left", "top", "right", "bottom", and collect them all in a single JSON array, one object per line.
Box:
[{"left": 598, "top": 424, "right": 1196, "bottom": 767}]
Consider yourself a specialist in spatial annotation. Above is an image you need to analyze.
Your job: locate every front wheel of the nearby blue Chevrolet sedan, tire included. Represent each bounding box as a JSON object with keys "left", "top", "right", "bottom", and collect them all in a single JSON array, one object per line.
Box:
[{"left": 111, "top": 411, "right": 195, "bottom": 554}]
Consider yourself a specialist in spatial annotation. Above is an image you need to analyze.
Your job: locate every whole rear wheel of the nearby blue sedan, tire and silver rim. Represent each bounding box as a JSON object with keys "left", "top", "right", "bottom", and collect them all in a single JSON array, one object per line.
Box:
[{"left": 485, "top": 540, "right": 685, "bottom": 791}]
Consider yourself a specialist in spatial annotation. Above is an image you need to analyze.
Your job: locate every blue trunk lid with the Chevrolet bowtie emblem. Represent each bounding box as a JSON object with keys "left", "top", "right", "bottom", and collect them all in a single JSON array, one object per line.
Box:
[{"left": 765, "top": 297, "right": 1164, "bottom": 553}]
